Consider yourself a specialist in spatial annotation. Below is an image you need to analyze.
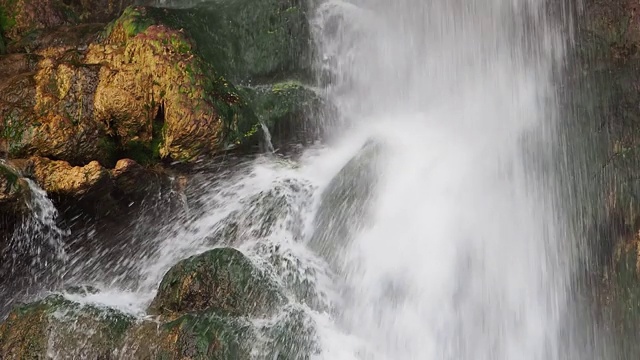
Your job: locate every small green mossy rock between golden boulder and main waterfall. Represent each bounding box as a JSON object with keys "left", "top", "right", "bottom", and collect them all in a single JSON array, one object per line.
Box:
[{"left": 246, "top": 81, "right": 325, "bottom": 148}]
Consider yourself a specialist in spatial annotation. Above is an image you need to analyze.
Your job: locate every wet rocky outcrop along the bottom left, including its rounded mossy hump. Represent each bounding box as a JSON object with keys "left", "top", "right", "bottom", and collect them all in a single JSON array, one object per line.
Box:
[{"left": 0, "top": 248, "right": 317, "bottom": 359}]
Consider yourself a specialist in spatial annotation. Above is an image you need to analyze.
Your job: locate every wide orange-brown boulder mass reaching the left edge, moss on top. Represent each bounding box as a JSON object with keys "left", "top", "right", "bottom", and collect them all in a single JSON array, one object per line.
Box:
[{"left": 0, "top": 8, "right": 256, "bottom": 166}]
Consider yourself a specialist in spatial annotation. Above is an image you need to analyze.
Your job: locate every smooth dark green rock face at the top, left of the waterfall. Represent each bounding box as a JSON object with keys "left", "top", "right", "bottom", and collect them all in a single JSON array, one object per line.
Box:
[{"left": 150, "top": 0, "right": 311, "bottom": 83}]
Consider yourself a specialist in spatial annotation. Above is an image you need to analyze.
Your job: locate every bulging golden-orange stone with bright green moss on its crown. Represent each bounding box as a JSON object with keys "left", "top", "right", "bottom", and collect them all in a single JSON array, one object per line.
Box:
[{"left": 86, "top": 7, "right": 257, "bottom": 161}]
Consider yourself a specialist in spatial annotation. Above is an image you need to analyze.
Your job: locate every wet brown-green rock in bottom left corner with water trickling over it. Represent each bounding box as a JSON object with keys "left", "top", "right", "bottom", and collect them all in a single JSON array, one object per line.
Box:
[{"left": 0, "top": 295, "right": 134, "bottom": 359}]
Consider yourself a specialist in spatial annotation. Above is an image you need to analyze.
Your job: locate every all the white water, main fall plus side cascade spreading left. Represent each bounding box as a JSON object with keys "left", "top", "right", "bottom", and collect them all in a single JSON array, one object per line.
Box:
[{"left": 2, "top": 0, "right": 608, "bottom": 360}]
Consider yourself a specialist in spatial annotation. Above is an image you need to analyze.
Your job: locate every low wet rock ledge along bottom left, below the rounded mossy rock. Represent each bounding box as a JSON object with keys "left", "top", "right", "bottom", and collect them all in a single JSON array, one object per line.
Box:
[{"left": 0, "top": 295, "right": 255, "bottom": 360}]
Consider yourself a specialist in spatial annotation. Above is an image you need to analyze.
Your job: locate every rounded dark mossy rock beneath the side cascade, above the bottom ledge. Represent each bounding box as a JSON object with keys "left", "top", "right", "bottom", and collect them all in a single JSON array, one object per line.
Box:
[{"left": 149, "top": 248, "right": 284, "bottom": 316}]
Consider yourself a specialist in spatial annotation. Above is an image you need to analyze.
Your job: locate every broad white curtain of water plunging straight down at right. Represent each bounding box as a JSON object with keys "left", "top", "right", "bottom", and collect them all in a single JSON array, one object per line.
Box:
[{"left": 308, "top": 0, "right": 570, "bottom": 359}]
